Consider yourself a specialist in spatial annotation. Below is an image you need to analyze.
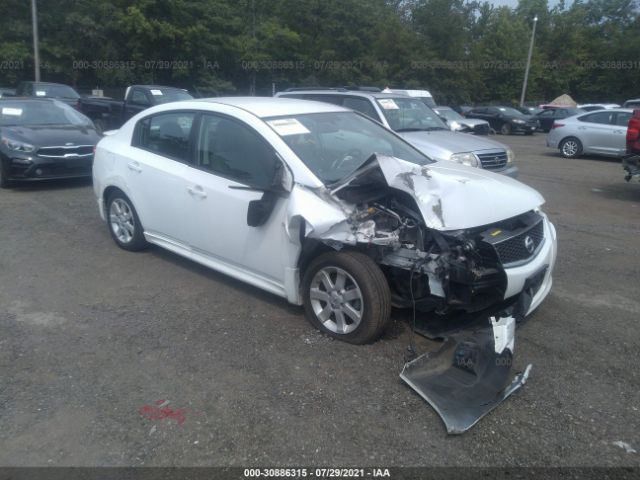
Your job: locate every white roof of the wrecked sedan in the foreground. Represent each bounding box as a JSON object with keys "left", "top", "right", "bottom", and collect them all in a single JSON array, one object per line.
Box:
[{"left": 195, "top": 97, "right": 350, "bottom": 118}]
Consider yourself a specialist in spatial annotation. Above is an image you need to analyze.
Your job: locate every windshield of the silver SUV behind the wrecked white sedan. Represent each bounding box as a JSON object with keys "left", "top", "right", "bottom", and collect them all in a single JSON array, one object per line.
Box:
[{"left": 376, "top": 97, "right": 449, "bottom": 132}]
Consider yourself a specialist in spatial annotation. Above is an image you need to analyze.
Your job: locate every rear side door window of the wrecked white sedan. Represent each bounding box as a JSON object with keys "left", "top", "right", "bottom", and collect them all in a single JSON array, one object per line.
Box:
[{"left": 135, "top": 112, "right": 195, "bottom": 163}]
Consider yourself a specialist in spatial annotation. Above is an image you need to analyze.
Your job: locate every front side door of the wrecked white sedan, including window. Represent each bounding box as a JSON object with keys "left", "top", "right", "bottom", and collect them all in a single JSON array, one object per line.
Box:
[{"left": 182, "top": 113, "right": 291, "bottom": 293}]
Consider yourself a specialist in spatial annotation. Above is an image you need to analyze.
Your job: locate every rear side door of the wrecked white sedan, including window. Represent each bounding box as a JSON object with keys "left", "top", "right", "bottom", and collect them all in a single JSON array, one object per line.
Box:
[{"left": 124, "top": 112, "right": 196, "bottom": 244}]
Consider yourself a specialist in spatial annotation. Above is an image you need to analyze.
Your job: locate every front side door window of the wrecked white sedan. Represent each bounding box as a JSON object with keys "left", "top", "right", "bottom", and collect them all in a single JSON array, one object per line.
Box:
[{"left": 197, "top": 115, "right": 279, "bottom": 187}]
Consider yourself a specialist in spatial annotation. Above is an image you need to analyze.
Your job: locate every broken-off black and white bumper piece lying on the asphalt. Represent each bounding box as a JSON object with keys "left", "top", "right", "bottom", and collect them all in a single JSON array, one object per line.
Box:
[{"left": 400, "top": 316, "right": 531, "bottom": 434}]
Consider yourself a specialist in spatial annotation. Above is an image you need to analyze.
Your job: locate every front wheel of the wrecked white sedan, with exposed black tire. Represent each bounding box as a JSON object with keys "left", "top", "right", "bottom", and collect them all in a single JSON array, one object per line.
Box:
[{"left": 302, "top": 251, "right": 391, "bottom": 345}]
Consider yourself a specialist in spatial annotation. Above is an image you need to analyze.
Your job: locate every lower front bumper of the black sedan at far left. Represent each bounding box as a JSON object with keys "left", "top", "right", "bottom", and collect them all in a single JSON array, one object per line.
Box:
[{"left": 4, "top": 156, "right": 93, "bottom": 181}]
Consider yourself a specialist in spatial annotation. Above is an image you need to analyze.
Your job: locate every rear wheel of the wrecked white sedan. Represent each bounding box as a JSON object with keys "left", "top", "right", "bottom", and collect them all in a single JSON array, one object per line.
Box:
[{"left": 106, "top": 190, "right": 148, "bottom": 252}]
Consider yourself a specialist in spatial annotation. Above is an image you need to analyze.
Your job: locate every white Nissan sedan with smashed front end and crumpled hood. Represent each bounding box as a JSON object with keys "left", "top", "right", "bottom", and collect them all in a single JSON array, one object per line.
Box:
[{"left": 93, "top": 97, "right": 556, "bottom": 343}]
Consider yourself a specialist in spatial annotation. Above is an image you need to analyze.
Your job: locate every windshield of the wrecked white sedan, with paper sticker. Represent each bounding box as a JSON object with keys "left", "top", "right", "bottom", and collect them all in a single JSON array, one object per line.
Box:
[{"left": 266, "top": 112, "right": 432, "bottom": 184}]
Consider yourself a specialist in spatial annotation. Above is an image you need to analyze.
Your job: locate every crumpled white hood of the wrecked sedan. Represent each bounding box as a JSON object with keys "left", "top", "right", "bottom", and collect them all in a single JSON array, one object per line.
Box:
[{"left": 362, "top": 155, "right": 544, "bottom": 231}]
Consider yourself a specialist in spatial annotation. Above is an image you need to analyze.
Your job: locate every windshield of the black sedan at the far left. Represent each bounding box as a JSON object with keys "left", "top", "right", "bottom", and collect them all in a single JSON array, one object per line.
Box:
[{"left": 0, "top": 100, "right": 91, "bottom": 127}]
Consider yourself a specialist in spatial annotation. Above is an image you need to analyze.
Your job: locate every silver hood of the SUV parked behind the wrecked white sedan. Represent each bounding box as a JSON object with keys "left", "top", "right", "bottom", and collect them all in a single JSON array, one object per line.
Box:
[{"left": 398, "top": 128, "right": 507, "bottom": 160}]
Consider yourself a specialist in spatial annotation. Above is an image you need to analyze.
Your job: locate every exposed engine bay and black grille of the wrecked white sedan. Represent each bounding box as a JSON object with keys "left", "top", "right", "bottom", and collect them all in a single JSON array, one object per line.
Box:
[{"left": 308, "top": 156, "right": 544, "bottom": 314}]
